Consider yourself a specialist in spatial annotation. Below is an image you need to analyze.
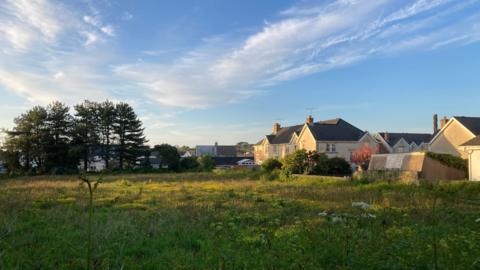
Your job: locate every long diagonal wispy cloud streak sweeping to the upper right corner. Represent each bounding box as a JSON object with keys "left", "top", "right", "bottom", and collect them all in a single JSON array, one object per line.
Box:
[{"left": 114, "top": 0, "right": 480, "bottom": 108}]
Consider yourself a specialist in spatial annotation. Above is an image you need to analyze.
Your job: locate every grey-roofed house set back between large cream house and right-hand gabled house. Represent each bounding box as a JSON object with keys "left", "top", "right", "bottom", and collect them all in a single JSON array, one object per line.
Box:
[{"left": 373, "top": 132, "right": 433, "bottom": 153}]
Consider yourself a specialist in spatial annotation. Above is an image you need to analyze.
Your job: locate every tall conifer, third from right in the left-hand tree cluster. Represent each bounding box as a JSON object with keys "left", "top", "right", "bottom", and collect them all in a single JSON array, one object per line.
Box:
[{"left": 72, "top": 100, "right": 100, "bottom": 171}]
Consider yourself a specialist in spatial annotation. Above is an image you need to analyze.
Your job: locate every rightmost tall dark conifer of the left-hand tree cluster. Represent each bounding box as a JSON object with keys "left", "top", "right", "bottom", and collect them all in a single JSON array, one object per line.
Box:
[{"left": 113, "top": 103, "right": 146, "bottom": 169}]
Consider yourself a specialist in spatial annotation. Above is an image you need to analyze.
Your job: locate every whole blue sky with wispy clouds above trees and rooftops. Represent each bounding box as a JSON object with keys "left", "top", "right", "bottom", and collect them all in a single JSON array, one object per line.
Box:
[{"left": 0, "top": 0, "right": 480, "bottom": 146}]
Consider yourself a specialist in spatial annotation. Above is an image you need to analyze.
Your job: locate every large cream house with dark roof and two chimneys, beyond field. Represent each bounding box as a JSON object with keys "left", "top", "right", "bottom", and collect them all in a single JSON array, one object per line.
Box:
[{"left": 254, "top": 116, "right": 378, "bottom": 164}]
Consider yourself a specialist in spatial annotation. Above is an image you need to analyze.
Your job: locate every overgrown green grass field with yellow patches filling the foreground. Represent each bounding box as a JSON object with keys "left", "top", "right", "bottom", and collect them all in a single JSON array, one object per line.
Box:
[{"left": 0, "top": 173, "right": 480, "bottom": 269}]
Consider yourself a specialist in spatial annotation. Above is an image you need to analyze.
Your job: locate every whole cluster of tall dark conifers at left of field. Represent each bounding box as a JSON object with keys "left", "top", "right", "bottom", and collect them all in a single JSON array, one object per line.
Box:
[{"left": 2, "top": 100, "right": 147, "bottom": 173}]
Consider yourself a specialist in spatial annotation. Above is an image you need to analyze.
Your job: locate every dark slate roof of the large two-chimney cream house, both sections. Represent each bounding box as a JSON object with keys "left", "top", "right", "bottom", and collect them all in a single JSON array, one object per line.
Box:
[{"left": 259, "top": 118, "right": 366, "bottom": 144}]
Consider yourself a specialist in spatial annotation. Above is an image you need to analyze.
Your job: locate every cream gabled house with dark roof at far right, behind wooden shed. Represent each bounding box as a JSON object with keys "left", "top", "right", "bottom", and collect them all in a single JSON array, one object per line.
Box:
[{"left": 428, "top": 116, "right": 480, "bottom": 159}]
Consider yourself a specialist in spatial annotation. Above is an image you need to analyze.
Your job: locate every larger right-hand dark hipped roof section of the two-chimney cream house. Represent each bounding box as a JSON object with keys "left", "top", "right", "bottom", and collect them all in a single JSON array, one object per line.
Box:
[{"left": 308, "top": 118, "right": 366, "bottom": 141}]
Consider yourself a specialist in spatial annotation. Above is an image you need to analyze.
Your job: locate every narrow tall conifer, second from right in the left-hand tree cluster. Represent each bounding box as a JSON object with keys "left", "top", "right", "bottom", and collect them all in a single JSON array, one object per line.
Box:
[{"left": 98, "top": 100, "right": 117, "bottom": 169}]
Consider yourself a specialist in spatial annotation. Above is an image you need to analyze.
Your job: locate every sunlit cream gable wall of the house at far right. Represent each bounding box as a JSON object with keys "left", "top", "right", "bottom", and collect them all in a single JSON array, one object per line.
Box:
[{"left": 429, "top": 120, "right": 475, "bottom": 159}]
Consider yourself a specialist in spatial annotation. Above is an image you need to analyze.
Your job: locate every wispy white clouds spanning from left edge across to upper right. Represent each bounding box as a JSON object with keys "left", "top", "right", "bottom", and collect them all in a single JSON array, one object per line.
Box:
[{"left": 0, "top": 0, "right": 480, "bottom": 112}]
